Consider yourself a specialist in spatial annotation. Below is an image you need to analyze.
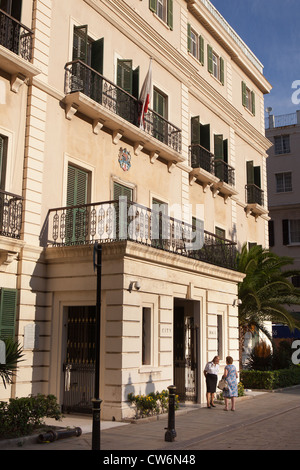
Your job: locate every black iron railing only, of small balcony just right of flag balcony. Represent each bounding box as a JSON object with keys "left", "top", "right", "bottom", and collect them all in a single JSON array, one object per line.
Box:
[{"left": 189, "top": 144, "right": 235, "bottom": 186}]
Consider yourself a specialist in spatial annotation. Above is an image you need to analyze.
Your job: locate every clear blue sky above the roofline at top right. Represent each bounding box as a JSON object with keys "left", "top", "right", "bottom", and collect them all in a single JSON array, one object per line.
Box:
[{"left": 211, "top": 0, "right": 300, "bottom": 116}]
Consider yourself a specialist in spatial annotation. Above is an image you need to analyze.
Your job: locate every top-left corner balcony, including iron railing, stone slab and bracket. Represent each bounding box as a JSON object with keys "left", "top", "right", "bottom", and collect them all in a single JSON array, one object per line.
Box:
[{"left": 0, "top": 10, "right": 40, "bottom": 88}]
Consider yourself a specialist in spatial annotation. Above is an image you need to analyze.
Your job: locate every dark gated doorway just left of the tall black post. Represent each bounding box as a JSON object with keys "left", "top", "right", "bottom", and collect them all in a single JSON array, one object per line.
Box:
[{"left": 63, "top": 306, "right": 96, "bottom": 413}]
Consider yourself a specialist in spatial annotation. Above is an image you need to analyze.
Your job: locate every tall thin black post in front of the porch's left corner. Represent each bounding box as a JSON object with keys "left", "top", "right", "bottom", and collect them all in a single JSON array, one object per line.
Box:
[{"left": 92, "top": 243, "right": 102, "bottom": 450}]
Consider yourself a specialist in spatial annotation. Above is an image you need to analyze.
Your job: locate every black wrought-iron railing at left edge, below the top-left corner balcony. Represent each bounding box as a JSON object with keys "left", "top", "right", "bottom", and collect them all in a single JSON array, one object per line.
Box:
[{"left": 0, "top": 190, "right": 23, "bottom": 238}]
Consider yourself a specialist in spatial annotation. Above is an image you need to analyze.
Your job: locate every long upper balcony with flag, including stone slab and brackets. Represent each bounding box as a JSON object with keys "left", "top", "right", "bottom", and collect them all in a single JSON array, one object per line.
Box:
[{"left": 63, "top": 60, "right": 184, "bottom": 168}]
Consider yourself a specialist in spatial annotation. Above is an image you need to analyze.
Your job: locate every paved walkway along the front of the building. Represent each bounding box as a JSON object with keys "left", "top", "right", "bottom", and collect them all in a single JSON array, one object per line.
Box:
[{"left": 0, "top": 386, "right": 300, "bottom": 452}]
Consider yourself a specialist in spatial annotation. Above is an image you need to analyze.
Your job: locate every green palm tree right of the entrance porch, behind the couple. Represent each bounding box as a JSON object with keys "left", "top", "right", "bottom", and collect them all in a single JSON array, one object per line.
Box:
[{"left": 237, "top": 245, "right": 300, "bottom": 370}]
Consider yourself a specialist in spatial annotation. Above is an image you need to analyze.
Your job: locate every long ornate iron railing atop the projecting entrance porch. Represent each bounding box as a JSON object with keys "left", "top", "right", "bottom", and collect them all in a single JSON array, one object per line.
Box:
[{"left": 41, "top": 198, "right": 236, "bottom": 269}]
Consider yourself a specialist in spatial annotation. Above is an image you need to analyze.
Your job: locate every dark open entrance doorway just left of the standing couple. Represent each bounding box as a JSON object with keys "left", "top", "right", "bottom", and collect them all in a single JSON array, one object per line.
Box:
[{"left": 174, "top": 299, "right": 200, "bottom": 403}]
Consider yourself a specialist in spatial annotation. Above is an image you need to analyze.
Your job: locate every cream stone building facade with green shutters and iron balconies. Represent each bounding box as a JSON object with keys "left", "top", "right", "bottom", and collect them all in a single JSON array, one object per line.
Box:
[{"left": 0, "top": 0, "right": 270, "bottom": 420}]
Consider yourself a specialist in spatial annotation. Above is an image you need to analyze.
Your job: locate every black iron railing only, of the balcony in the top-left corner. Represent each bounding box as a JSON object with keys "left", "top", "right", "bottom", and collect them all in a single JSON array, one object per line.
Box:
[{"left": 0, "top": 10, "right": 33, "bottom": 62}]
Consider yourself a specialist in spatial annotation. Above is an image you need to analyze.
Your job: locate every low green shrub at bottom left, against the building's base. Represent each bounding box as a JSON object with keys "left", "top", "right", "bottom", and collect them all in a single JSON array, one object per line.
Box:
[{"left": 0, "top": 394, "right": 62, "bottom": 438}]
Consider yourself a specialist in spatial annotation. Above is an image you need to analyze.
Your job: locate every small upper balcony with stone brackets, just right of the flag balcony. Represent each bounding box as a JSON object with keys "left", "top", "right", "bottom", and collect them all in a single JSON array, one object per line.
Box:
[{"left": 189, "top": 144, "right": 237, "bottom": 201}]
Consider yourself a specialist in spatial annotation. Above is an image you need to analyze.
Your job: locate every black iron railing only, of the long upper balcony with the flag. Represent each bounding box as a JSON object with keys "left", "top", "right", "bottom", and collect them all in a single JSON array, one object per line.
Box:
[{"left": 65, "top": 60, "right": 181, "bottom": 153}]
